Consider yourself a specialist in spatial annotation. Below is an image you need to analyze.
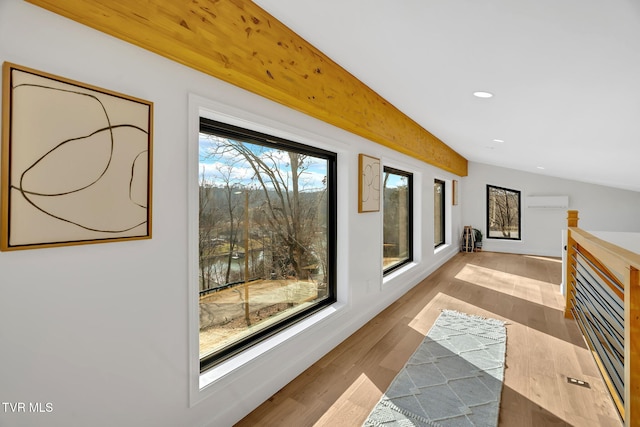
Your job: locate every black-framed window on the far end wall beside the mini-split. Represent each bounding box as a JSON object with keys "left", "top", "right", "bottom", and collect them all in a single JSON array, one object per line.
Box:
[{"left": 487, "top": 185, "right": 522, "bottom": 240}]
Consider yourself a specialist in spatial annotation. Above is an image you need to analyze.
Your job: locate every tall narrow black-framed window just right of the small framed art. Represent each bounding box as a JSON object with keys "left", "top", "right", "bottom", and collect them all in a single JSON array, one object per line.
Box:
[{"left": 382, "top": 166, "right": 413, "bottom": 274}]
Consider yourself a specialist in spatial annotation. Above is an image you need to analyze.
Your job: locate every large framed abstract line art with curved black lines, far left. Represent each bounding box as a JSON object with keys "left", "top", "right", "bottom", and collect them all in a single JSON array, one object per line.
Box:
[{"left": 0, "top": 62, "right": 153, "bottom": 251}]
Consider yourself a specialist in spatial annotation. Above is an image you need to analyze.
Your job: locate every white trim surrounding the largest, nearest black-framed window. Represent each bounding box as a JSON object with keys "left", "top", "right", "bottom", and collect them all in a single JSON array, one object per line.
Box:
[{"left": 187, "top": 94, "right": 351, "bottom": 407}]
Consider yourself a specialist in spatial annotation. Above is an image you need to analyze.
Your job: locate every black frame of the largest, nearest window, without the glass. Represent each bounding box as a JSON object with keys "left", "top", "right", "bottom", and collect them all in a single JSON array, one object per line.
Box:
[{"left": 199, "top": 114, "right": 338, "bottom": 373}]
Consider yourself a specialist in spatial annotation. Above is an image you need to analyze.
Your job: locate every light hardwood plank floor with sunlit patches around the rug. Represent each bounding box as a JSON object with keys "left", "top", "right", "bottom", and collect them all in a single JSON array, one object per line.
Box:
[{"left": 237, "top": 252, "right": 622, "bottom": 427}]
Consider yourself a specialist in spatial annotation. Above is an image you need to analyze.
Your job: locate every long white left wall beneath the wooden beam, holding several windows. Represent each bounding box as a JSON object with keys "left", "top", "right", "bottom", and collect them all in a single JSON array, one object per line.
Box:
[{"left": 0, "top": 0, "right": 463, "bottom": 427}]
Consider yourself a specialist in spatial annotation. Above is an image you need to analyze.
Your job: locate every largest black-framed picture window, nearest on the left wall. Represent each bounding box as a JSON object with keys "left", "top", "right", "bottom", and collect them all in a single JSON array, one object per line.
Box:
[{"left": 198, "top": 118, "right": 336, "bottom": 370}]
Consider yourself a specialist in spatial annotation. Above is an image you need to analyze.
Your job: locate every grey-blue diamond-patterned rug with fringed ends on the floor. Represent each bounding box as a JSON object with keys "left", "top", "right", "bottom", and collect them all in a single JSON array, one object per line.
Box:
[{"left": 363, "top": 310, "right": 507, "bottom": 427}]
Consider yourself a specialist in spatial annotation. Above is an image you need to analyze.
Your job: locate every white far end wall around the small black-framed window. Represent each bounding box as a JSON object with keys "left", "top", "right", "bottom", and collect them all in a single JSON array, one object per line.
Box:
[{"left": 461, "top": 162, "right": 640, "bottom": 256}]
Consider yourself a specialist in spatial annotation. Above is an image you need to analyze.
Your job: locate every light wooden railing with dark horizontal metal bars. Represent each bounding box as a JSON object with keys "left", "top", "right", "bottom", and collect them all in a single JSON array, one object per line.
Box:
[{"left": 564, "top": 210, "right": 640, "bottom": 426}]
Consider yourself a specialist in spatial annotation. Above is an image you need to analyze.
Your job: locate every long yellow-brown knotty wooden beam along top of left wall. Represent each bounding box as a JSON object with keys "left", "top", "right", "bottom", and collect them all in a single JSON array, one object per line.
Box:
[{"left": 26, "top": 0, "right": 467, "bottom": 176}]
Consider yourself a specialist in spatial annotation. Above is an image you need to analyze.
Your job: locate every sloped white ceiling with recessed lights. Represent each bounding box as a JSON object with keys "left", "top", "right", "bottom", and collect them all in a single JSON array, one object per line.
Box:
[{"left": 254, "top": 0, "right": 640, "bottom": 191}]
